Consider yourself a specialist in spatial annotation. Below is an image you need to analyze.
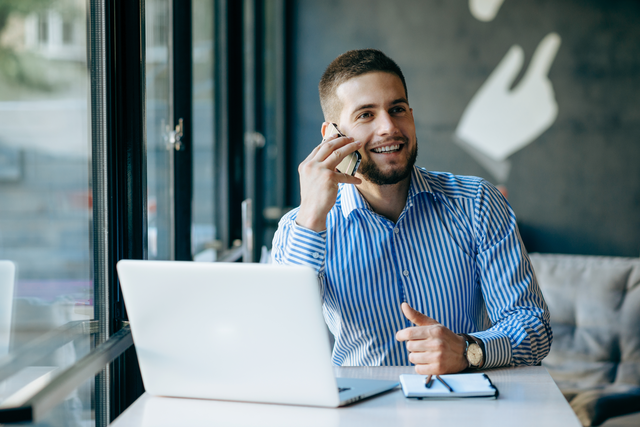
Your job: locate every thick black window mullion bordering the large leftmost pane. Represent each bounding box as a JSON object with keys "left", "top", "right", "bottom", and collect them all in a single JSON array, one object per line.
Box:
[{"left": 103, "top": 0, "right": 147, "bottom": 421}]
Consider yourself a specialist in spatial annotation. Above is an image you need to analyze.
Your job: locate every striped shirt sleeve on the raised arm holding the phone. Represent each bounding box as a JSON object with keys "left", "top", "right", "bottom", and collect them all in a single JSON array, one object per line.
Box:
[{"left": 271, "top": 209, "right": 327, "bottom": 277}]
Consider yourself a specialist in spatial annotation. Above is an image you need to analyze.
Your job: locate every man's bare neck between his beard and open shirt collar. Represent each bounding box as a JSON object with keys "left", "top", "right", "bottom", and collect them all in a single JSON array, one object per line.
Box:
[{"left": 356, "top": 176, "right": 411, "bottom": 223}]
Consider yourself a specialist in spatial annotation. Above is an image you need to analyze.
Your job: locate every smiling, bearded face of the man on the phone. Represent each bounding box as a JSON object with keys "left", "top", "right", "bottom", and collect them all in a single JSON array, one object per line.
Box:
[{"left": 336, "top": 72, "right": 418, "bottom": 185}]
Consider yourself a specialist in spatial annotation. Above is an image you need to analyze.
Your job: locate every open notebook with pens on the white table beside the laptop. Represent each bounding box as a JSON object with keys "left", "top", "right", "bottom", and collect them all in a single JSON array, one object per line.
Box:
[{"left": 400, "top": 373, "right": 499, "bottom": 399}]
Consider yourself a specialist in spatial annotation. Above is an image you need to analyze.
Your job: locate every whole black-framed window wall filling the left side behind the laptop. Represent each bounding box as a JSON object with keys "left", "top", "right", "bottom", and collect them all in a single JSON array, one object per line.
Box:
[{"left": 0, "top": 0, "right": 284, "bottom": 427}]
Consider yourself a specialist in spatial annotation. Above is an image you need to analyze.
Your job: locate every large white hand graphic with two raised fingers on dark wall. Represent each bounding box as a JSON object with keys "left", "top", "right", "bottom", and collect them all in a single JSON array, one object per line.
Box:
[{"left": 456, "top": 33, "right": 560, "bottom": 161}]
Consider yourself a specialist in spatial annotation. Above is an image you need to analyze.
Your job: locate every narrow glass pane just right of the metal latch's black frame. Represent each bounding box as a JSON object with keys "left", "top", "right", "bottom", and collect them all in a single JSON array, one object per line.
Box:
[{"left": 191, "top": 0, "right": 220, "bottom": 261}]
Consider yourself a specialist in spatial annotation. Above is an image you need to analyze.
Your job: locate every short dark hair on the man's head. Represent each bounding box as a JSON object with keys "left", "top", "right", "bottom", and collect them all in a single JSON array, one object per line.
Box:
[{"left": 318, "top": 49, "right": 409, "bottom": 121}]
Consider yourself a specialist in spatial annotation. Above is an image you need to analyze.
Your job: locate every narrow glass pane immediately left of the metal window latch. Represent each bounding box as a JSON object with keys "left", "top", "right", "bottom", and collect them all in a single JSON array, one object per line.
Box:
[{"left": 145, "top": 0, "right": 173, "bottom": 259}]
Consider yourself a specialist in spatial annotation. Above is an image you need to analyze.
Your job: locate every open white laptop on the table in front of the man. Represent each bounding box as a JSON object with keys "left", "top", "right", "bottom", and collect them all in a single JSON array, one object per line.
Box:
[{"left": 117, "top": 260, "right": 399, "bottom": 407}]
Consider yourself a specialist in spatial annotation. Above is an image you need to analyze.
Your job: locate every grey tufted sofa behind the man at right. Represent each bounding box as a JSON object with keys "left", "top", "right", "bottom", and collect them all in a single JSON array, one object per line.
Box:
[{"left": 530, "top": 254, "right": 640, "bottom": 427}]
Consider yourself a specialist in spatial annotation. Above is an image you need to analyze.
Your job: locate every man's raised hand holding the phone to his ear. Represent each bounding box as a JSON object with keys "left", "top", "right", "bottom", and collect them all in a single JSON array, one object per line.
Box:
[{"left": 296, "top": 123, "right": 362, "bottom": 232}]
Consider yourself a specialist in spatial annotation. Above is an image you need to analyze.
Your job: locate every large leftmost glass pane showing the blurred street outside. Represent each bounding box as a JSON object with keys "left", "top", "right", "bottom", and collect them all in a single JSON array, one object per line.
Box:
[{"left": 0, "top": 0, "right": 93, "bottom": 426}]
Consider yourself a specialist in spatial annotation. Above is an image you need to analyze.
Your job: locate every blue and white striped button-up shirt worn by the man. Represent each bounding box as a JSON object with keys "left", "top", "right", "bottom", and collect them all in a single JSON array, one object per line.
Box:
[{"left": 272, "top": 167, "right": 552, "bottom": 368}]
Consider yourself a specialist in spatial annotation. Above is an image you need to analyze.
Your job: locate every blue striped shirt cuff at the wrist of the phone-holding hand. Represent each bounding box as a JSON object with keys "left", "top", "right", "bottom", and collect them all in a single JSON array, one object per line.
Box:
[{"left": 288, "top": 221, "right": 327, "bottom": 273}]
